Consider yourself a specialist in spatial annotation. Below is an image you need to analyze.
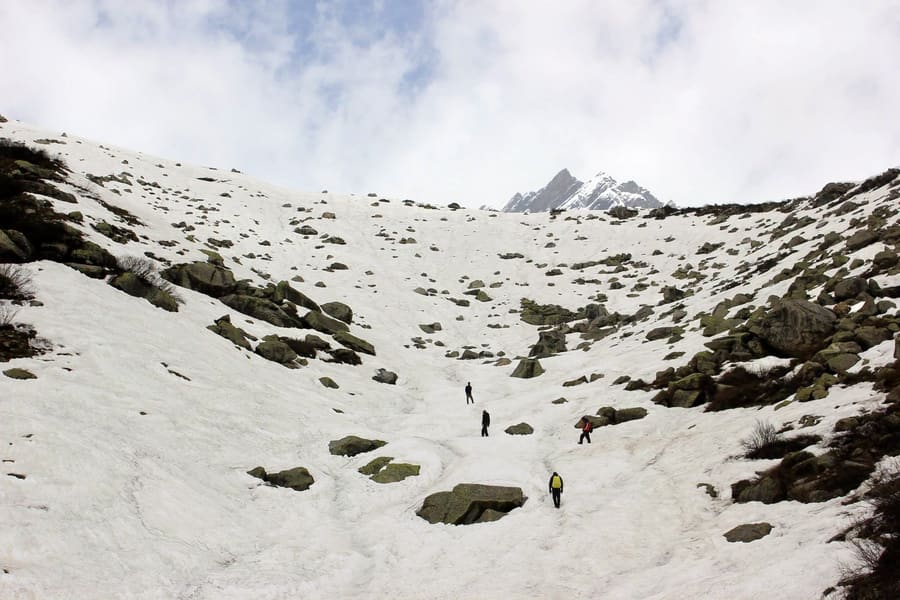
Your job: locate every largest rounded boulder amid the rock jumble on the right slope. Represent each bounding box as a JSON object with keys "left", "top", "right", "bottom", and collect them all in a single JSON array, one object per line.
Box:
[{"left": 750, "top": 299, "right": 837, "bottom": 358}]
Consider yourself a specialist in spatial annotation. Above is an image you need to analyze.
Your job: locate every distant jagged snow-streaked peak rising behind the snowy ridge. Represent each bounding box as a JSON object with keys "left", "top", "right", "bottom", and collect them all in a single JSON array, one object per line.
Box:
[{"left": 503, "top": 169, "right": 663, "bottom": 212}]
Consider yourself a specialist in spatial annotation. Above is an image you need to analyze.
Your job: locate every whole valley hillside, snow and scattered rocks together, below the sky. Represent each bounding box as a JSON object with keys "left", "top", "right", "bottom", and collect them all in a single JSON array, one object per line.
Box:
[{"left": 0, "top": 113, "right": 900, "bottom": 598}]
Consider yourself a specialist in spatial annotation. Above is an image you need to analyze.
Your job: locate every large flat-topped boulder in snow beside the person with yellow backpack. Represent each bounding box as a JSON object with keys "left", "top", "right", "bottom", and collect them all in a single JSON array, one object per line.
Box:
[{"left": 416, "top": 483, "right": 527, "bottom": 525}]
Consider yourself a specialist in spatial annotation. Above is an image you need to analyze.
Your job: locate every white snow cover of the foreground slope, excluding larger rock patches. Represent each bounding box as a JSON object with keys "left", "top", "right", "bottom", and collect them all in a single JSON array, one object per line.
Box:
[{"left": 0, "top": 116, "right": 900, "bottom": 598}]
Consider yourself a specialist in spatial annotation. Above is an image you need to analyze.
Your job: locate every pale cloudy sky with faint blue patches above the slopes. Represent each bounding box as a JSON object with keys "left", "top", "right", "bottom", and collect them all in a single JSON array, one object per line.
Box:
[{"left": 0, "top": 0, "right": 900, "bottom": 206}]
